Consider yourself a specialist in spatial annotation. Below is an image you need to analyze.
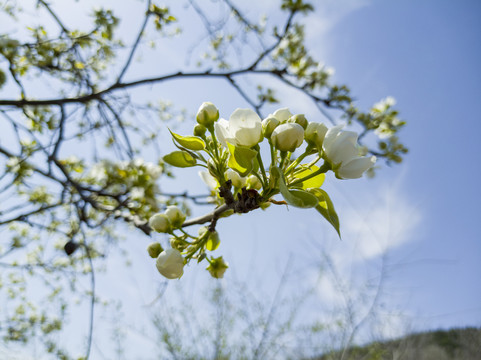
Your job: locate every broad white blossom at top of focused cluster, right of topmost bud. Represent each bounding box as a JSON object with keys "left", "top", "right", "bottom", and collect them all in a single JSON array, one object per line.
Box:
[{"left": 214, "top": 109, "right": 262, "bottom": 147}]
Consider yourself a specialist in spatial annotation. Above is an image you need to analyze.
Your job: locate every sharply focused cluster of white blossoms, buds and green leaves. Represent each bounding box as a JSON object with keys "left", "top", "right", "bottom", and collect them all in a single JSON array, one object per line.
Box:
[{"left": 148, "top": 102, "right": 376, "bottom": 279}]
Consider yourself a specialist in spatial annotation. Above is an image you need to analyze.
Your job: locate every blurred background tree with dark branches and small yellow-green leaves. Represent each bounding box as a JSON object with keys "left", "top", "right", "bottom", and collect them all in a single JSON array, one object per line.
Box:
[{"left": 0, "top": 0, "right": 407, "bottom": 358}]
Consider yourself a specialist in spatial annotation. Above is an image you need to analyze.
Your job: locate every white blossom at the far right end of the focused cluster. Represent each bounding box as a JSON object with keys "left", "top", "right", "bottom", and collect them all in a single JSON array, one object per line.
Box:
[{"left": 322, "top": 125, "right": 376, "bottom": 179}]
